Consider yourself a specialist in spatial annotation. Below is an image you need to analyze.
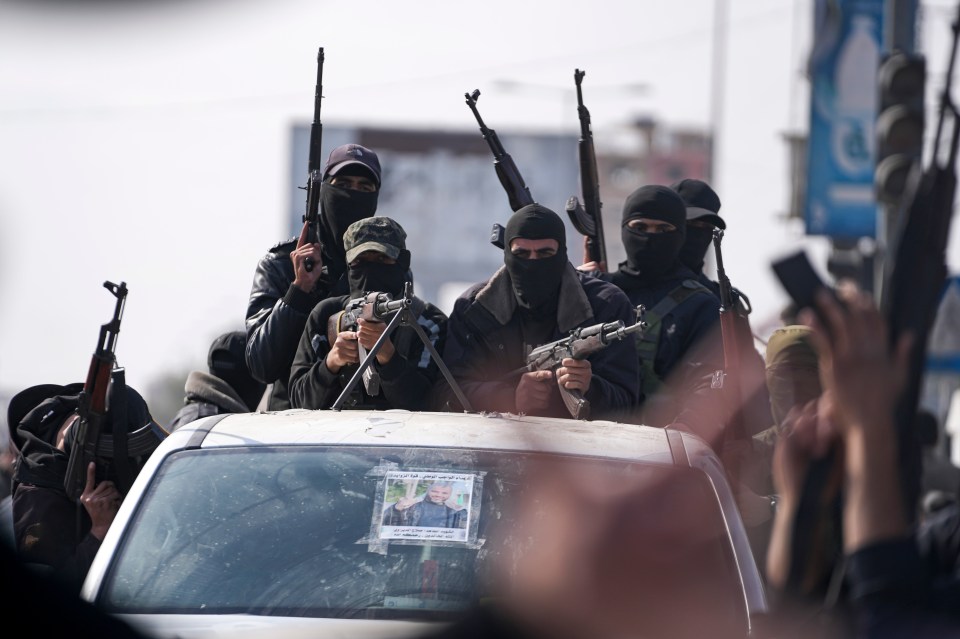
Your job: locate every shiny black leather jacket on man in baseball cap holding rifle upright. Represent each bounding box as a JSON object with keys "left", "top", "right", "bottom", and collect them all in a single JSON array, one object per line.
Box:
[{"left": 246, "top": 238, "right": 348, "bottom": 410}]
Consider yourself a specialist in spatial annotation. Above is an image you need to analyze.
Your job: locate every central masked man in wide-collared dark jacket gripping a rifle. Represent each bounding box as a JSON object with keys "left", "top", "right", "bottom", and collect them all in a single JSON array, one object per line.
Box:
[{"left": 439, "top": 204, "right": 639, "bottom": 418}]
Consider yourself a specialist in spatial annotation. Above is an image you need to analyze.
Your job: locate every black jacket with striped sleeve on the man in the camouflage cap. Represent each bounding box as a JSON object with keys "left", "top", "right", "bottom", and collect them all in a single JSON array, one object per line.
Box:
[{"left": 289, "top": 295, "right": 447, "bottom": 410}]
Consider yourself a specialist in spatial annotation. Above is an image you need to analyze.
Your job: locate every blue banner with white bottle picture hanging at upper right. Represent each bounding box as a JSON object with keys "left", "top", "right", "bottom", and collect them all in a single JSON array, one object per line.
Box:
[{"left": 804, "top": 0, "right": 883, "bottom": 238}]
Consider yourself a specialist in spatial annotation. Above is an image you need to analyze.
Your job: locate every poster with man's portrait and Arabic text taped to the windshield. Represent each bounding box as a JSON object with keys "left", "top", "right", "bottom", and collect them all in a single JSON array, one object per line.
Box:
[{"left": 379, "top": 471, "right": 476, "bottom": 541}]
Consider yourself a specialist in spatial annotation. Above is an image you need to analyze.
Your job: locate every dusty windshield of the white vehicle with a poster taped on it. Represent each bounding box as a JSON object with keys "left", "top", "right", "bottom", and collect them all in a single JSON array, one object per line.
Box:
[{"left": 97, "top": 446, "right": 745, "bottom": 627}]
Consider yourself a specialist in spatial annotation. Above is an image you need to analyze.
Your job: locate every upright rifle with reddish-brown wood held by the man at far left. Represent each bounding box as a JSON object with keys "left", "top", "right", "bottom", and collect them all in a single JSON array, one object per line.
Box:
[{"left": 63, "top": 282, "right": 127, "bottom": 500}]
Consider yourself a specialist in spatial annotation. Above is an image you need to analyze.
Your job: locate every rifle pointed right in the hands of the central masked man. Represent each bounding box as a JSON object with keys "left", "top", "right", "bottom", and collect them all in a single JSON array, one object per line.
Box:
[{"left": 516, "top": 305, "right": 647, "bottom": 419}]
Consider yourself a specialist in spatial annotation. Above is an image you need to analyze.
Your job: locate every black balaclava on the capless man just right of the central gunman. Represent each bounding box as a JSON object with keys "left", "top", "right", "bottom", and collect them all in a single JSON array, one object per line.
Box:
[{"left": 620, "top": 184, "right": 687, "bottom": 277}]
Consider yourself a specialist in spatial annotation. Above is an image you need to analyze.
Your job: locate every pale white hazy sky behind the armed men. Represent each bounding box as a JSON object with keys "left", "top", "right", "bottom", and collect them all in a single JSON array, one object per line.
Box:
[{"left": 0, "top": 0, "right": 958, "bottom": 404}]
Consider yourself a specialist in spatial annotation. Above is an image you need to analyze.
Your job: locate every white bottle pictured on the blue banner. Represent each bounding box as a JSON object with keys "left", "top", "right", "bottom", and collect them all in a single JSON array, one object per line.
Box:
[{"left": 832, "top": 15, "right": 880, "bottom": 177}]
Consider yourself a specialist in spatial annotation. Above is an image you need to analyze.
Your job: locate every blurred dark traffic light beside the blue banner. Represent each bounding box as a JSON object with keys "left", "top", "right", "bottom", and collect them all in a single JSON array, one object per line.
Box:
[{"left": 874, "top": 51, "right": 927, "bottom": 204}]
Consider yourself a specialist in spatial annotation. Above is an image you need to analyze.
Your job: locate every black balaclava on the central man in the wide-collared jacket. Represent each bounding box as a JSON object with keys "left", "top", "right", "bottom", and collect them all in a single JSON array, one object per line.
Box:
[{"left": 503, "top": 204, "right": 567, "bottom": 310}]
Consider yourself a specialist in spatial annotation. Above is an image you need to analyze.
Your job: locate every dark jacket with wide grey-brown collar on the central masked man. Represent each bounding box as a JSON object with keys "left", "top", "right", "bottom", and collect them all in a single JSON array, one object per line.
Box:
[{"left": 438, "top": 265, "right": 640, "bottom": 418}]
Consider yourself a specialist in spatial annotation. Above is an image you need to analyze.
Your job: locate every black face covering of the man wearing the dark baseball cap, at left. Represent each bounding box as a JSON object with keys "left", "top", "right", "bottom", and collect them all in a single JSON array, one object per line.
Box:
[{"left": 320, "top": 165, "right": 380, "bottom": 270}]
